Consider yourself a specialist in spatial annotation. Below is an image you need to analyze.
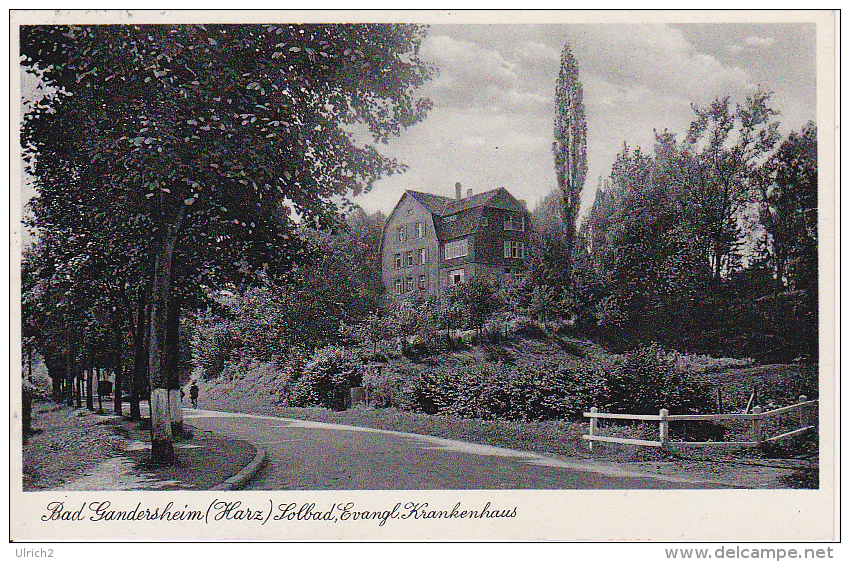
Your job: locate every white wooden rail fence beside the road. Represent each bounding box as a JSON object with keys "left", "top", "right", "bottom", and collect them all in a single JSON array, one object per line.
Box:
[{"left": 583, "top": 395, "right": 818, "bottom": 450}]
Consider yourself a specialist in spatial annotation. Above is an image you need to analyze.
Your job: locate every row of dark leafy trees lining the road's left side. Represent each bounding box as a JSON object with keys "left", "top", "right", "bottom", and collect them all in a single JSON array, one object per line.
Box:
[{"left": 21, "top": 25, "right": 433, "bottom": 462}]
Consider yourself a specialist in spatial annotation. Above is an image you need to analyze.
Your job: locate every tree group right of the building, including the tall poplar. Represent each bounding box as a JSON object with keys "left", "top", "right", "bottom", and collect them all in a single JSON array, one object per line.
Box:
[{"left": 531, "top": 45, "right": 818, "bottom": 361}]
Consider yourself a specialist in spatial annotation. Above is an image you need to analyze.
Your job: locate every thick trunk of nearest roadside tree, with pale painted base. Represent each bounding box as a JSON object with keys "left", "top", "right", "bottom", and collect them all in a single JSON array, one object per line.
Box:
[{"left": 148, "top": 233, "right": 176, "bottom": 464}]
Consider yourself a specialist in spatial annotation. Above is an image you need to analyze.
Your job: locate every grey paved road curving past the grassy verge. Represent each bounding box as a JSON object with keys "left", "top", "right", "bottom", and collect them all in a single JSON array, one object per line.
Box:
[{"left": 184, "top": 409, "right": 721, "bottom": 490}]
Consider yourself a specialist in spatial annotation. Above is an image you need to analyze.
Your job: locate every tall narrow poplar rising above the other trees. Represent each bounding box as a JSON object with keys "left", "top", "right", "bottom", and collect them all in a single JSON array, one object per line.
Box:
[{"left": 552, "top": 43, "right": 587, "bottom": 281}]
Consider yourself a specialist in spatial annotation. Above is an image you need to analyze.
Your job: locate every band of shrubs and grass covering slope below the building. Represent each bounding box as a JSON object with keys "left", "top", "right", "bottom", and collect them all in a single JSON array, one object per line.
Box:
[{"left": 202, "top": 328, "right": 817, "bottom": 422}]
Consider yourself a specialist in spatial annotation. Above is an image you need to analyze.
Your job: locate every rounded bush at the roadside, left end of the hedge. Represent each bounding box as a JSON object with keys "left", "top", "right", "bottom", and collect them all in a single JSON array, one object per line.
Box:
[{"left": 290, "top": 346, "right": 361, "bottom": 410}]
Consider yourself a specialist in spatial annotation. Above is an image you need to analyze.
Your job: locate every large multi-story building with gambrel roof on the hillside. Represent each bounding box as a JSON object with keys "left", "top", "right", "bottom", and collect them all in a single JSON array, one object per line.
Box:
[{"left": 381, "top": 183, "right": 531, "bottom": 296}]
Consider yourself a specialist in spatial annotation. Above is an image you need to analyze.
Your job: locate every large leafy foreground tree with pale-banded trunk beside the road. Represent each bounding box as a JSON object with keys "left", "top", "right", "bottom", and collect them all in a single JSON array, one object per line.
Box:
[{"left": 21, "top": 25, "right": 431, "bottom": 462}]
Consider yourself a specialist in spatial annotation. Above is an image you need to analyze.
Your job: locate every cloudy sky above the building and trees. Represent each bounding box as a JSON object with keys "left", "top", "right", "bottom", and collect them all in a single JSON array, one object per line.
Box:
[{"left": 355, "top": 20, "right": 816, "bottom": 217}]
